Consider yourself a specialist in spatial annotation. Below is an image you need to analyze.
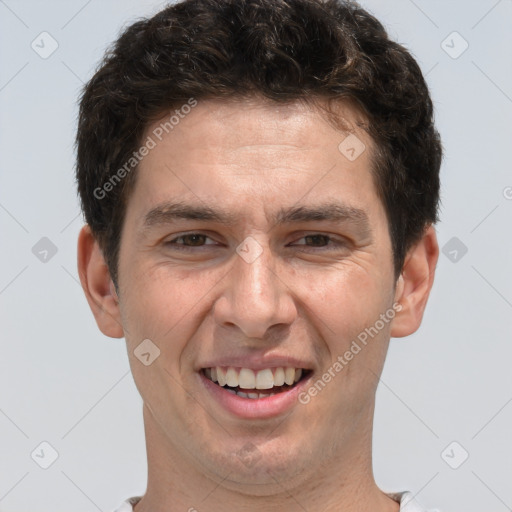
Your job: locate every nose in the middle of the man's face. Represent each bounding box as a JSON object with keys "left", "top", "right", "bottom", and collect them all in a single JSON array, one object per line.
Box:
[{"left": 214, "top": 240, "right": 297, "bottom": 338}]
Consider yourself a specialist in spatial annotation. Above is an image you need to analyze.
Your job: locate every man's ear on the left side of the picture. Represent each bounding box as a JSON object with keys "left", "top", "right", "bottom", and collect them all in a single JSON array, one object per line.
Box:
[{"left": 78, "top": 225, "right": 124, "bottom": 338}]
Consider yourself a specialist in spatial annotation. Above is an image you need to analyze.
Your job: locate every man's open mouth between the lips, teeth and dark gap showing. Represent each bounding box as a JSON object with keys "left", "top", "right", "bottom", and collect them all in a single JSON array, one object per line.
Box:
[{"left": 201, "top": 366, "right": 311, "bottom": 400}]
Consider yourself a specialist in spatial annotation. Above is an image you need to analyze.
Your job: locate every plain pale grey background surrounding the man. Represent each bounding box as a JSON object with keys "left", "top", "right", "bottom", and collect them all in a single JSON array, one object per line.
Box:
[{"left": 0, "top": 0, "right": 512, "bottom": 512}]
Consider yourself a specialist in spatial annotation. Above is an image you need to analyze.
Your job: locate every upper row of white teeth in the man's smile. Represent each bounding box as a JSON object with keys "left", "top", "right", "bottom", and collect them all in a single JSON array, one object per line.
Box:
[{"left": 204, "top": 366, "right": 302, "bottom": 389}]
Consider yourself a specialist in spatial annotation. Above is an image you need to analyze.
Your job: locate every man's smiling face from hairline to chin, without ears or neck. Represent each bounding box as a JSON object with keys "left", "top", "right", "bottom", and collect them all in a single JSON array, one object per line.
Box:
[{"left": 119, "top": 101, "right": 395, "bottom": 484}]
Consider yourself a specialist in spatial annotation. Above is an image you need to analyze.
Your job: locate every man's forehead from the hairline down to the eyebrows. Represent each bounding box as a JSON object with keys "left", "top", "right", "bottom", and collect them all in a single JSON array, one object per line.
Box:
[{"left": 129, "top": 98, "right": 386, "bottom": 228}]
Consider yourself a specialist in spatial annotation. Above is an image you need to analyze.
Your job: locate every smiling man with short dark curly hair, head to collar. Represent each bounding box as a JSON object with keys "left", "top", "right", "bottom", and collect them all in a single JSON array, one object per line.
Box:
[{"left": 77, "top": 0, "right": 441, "bottom": 512}]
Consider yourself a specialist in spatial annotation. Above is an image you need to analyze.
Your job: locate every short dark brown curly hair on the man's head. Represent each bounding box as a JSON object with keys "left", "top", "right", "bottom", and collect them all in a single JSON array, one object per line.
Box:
[{"left": 76, "top": 0, "right": 442, "bottom": 286}]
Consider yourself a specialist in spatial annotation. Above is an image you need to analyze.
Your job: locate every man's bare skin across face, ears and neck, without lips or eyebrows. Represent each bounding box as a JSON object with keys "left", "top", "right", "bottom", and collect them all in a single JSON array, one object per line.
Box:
[{"left": 78, "top": 99, "right": 439, "bottom": 512}]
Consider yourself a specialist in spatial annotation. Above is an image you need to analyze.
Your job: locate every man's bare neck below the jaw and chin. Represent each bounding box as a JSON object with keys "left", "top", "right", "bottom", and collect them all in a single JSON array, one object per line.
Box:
[{"left": 134, "top": 406, "right": 399, "bottom": 512}]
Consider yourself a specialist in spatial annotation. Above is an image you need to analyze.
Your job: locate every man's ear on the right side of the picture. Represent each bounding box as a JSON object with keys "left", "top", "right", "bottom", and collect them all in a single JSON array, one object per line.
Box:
[{"left": 391, "top": 226, "right": 439, "bottom": 338}]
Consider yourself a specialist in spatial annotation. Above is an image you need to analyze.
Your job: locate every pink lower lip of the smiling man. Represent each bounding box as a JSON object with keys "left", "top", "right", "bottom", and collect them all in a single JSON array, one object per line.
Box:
[{"left": 199, "top": 373, "right": 311, "bottom": 419}]
